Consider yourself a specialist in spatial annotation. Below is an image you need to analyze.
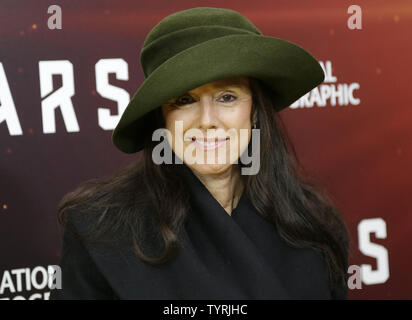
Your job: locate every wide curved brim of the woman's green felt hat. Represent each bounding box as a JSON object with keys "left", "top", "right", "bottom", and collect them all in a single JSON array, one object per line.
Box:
[{"left": 112, "top": 35, "right": 325, "bottom": 153}]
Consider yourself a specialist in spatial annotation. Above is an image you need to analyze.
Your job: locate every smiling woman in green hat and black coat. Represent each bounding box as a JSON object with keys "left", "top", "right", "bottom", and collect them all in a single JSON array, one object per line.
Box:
[{"left": 51, "top": 7, "right": 348, "bottom": 299}]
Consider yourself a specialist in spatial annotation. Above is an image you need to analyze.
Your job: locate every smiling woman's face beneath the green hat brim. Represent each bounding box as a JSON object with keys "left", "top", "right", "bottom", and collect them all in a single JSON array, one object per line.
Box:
[{"left": 162, "top": 77, "right": 252, "bottom": 174}]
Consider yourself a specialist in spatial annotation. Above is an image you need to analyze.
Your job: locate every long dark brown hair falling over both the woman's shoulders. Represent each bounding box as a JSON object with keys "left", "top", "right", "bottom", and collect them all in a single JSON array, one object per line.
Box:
[{"left": 58, "top": 78, "right": 349, "bottom": 296}]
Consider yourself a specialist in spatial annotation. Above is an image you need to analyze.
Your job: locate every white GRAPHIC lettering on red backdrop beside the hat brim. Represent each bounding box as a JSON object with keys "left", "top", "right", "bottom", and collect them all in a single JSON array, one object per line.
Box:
[{"left": 290, "top": 60, "right": 360, "bottom": 109}]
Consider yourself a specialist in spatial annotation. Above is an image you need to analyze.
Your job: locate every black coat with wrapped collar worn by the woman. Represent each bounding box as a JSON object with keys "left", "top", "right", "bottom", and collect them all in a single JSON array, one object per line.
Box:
[{"left": 50, "top": 165, "right": 347, "bottom": 299}]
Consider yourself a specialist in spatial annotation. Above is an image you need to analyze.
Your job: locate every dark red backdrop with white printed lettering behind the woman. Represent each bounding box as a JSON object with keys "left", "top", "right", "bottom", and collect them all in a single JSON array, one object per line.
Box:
[{"left": 0, "top": 0, "right": 412, "bottom": 299}]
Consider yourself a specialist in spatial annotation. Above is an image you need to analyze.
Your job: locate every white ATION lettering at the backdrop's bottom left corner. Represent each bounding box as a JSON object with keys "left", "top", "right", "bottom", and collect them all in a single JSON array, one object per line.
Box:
[{"left": 0, "top": 265, "right": 62, "bottom": 300}]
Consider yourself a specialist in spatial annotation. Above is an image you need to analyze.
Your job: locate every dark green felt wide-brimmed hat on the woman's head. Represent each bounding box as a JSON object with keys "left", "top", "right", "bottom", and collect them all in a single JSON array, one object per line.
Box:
[{"left": 112, "top": 7, "right": 324, "bottom": 153}]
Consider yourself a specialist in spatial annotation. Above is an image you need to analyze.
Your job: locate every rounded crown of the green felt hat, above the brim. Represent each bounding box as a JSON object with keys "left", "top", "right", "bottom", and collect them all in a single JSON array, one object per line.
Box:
[{"left": 140, "top": 7, "right": 262, "bottom": 78}]
